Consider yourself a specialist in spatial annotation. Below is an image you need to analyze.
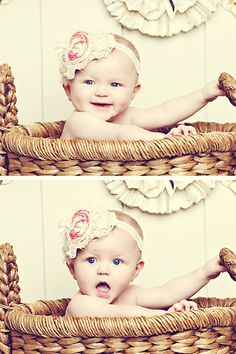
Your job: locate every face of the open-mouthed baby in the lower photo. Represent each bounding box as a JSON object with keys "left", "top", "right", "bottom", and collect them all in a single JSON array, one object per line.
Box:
[{"left": 70, "top": 227, "right": 142, "bottom": 303}]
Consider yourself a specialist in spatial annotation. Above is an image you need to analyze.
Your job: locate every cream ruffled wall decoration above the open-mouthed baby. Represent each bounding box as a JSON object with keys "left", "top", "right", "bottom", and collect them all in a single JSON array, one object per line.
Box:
[{"left": 105, "top": 180, "right": 215, "bottom": 214}]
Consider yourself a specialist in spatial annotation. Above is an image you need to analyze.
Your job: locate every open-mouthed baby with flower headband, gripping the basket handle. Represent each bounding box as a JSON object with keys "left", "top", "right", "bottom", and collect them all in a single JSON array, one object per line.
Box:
[{"left": 61, "top": 208, "right": 226, "bottom": 317}]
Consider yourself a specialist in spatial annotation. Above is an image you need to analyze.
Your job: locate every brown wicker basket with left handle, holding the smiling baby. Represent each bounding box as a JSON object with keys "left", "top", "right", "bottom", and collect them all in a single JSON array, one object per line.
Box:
[{"left": 0, "top": 64, "right": 236, "bottom": 176}]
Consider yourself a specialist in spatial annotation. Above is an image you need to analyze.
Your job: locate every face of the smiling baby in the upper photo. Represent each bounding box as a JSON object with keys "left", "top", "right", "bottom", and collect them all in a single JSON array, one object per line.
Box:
[{"left": 63, "top": 50, "right": 139, "bottom": 121}]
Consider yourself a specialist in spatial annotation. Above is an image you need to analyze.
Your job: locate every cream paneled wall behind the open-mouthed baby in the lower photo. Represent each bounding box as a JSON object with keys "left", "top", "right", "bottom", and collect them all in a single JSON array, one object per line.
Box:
[{"left": 0, "top": 178, "right": 236, "bottom": 302}]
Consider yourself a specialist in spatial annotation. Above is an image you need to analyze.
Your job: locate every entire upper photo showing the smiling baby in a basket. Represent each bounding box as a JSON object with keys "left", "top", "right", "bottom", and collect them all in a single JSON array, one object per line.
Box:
[{"left": 0, "top": 0, "right": 236, "bottom": 177}]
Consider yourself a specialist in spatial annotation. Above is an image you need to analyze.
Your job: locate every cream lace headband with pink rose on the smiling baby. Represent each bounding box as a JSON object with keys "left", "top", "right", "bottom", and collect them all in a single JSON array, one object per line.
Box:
[{"left": 57, "top": 31, "right": 140, "bottom": 82}]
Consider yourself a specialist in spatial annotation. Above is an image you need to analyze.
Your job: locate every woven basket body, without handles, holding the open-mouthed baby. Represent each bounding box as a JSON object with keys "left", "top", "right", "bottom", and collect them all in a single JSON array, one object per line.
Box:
[{"left": 1, "top": 245, "right": 236, "bottom": 354}]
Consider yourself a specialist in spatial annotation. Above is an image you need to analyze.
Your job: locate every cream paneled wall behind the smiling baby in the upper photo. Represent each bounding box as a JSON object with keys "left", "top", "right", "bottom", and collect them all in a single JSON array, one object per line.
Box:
[{"left": 0, "top": 0, "right": 236, "bottom": 124}]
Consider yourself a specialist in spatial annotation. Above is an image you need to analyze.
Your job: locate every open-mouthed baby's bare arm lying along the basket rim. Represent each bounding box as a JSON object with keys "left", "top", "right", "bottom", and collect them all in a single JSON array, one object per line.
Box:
[{"left": 66, "top": 294, "right": 166, "bottom": 317}]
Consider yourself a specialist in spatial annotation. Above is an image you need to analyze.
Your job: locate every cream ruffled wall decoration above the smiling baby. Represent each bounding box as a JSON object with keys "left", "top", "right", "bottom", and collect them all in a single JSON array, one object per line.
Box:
[{"left": 104, "top": 0, "right": 220, "bottom": 37}]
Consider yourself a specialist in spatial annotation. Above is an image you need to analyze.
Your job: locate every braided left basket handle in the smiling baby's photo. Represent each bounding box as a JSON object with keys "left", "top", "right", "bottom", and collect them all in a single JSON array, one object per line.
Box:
[{"left": 0, "top": 64, "right": 18, "bottom": 128}]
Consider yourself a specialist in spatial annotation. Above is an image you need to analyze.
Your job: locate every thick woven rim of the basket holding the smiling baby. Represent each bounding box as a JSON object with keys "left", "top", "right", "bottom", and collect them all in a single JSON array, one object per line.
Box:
[{"left": 2, "top": 121, "right": 236, "bottom": 161}]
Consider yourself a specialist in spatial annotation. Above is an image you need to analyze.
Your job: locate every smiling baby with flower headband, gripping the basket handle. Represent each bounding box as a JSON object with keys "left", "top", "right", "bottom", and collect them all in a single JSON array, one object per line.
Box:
[{"left": 58, "top": 31, "right": 225, "bottom": 140}]
